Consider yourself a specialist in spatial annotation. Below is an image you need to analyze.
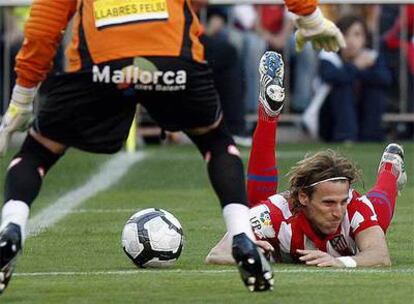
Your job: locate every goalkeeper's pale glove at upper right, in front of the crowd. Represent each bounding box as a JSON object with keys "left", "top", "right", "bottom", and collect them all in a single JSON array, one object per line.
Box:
[{"left": 295, "top": 8, "right": 346, "bottom": 52}]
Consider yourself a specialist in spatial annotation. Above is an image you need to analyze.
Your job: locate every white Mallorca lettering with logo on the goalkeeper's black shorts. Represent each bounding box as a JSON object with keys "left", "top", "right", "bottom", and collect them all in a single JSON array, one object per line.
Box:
[{"left": 92, "top": 65, "right": 187, "bottom": 91}]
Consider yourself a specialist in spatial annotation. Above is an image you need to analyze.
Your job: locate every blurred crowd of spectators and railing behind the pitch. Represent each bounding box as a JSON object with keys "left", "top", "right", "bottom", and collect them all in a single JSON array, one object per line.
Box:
[{"left": 0, "top": 0, "right": 414, "bottom": 146}]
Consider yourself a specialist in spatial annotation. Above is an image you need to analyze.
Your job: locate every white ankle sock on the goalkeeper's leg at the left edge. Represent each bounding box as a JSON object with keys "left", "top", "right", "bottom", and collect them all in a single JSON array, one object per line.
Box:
[{"left": 0, "top": 200, "right": 30, "bottom": 243}]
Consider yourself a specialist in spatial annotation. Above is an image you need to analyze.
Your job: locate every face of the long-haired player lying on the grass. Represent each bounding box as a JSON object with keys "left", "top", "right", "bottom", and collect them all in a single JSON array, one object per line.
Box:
[{"left": 299, "top": 182, "right": 350, "bottom": 235}]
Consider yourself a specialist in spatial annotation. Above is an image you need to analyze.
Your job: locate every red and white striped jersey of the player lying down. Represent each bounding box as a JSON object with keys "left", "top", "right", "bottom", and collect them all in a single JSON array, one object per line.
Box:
[{"left": 250, "top": 190, "right": 378, "bottom": 263}]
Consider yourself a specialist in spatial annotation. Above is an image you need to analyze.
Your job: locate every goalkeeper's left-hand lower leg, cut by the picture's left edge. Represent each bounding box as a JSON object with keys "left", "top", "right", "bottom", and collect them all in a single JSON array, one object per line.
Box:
[{"left": 0, "top": 135, "right": 62, "bottom": 294}]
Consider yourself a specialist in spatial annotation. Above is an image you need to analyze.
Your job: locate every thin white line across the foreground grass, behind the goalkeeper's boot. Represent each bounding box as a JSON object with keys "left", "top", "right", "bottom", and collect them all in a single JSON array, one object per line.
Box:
[{"left": 14, "top": 265, "right": 414, "bottom": 277}]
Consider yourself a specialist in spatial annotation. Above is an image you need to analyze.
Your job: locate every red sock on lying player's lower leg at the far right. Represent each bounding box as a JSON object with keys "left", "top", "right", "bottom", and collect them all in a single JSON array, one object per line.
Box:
[{"left": 367, "top": 163, "right": 398, "bottom": 233}]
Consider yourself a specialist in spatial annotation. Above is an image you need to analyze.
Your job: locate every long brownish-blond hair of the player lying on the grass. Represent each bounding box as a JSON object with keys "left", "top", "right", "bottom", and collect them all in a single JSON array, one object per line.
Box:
[{"left": 288, "top": 149, "right": 361, "bottom": 212}]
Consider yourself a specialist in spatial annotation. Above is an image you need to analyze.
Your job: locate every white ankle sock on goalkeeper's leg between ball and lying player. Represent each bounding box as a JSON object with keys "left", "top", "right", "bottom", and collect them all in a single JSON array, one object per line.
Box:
[{"left": 223, "top": 204, "right": 256, "bottom": 240}]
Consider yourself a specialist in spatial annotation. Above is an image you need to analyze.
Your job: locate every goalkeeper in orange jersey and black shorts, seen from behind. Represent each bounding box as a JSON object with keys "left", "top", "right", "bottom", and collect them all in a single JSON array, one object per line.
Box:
[{"left": 0, "top": 0, "right": 343, "bottom": 293}]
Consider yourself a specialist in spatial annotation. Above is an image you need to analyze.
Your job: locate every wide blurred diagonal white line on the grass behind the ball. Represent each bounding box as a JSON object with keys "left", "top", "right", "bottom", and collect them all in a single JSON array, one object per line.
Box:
[{"left": 27, "top": 152, "right": 146, "bottom": 237}]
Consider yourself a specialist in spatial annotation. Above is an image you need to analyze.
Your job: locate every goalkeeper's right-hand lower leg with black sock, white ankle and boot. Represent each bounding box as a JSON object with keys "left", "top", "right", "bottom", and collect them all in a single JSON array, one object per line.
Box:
[{"left": 188, "top": 122, "right": 273, "bottom": 291}]
